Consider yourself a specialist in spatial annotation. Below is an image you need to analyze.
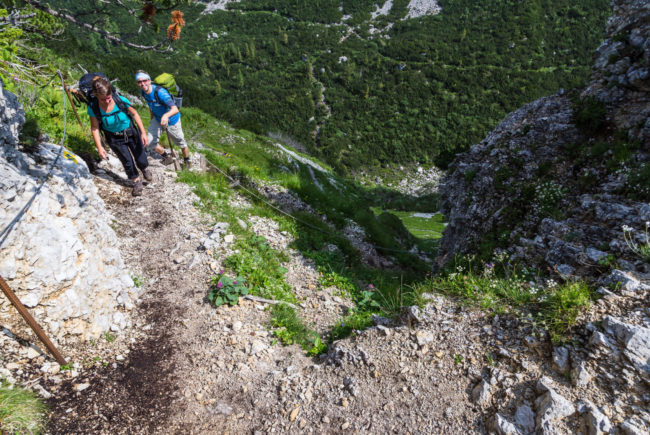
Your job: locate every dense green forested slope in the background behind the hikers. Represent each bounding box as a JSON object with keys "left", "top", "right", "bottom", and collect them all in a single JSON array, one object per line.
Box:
[{"left": 47, "top": 0, "right": 609, "bottom": 173}]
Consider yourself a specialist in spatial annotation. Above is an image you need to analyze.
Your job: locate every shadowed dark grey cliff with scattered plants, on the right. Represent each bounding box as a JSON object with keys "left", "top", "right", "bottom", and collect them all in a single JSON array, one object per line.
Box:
[{"left": 438, "top": 0, "right": 650, "bottom": 282}]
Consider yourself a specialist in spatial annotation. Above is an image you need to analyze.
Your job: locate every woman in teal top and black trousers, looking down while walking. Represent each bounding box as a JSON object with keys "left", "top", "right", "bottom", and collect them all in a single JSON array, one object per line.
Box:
[{"left": 88, "top": 77, "right": 153, "bottom": 196}]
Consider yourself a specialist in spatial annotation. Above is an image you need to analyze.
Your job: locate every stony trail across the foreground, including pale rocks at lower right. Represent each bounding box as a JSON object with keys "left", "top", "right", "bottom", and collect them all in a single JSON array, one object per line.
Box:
[{"left": 25, "top": 154, "right": 648, "bottom": 434}]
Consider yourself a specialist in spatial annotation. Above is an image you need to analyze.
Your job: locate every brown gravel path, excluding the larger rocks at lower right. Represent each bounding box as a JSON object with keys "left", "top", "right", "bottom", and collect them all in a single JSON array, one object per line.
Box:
[{"left": 40, "top": 158, "right": 481, "bottom": 434}]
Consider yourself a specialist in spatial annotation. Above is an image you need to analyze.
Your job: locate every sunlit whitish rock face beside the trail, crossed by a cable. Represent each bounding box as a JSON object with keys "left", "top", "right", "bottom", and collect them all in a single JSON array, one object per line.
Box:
[{"left": 0, "top": 87, "right": 137, "bottom": 343}]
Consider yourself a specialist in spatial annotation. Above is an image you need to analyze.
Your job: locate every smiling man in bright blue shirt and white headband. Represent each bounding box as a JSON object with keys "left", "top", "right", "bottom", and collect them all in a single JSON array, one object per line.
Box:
[{"left": 135, "top": 70, "right": 190, "bottom": 169}]
